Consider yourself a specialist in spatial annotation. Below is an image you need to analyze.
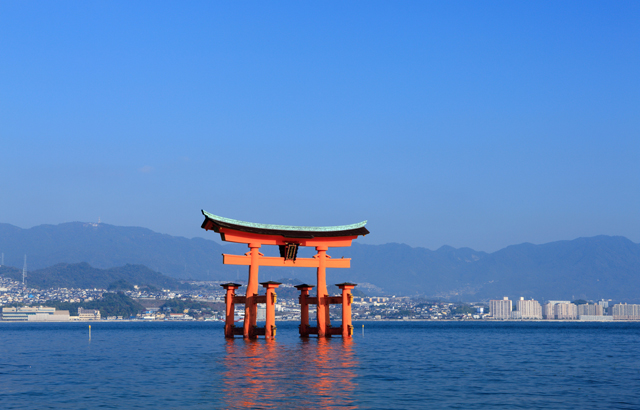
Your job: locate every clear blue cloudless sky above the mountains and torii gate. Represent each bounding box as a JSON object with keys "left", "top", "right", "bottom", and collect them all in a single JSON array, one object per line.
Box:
[{"left": 0, "top": 1, "right": 640, "bottom": 251}]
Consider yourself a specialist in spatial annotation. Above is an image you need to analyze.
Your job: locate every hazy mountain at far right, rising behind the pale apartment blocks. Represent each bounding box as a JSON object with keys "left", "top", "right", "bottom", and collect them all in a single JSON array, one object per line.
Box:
[{"left": 465, "top": 235, "right": 640, "bottom": 301}]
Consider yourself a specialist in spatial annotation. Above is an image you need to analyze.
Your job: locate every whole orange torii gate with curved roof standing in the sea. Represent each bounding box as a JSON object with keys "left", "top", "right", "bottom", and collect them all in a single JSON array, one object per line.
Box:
[{"left": 202, "top": 210, "right": 369, "bottom": 339}]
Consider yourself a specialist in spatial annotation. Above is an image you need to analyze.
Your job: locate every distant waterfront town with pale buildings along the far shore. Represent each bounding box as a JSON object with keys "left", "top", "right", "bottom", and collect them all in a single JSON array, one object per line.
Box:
[{"left": 0, "top": 277, "right": 640, "bottom": 322}]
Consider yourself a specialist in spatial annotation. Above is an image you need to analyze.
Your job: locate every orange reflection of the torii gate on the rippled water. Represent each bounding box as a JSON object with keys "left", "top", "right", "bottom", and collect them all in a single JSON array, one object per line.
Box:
[{"left": 222, "top": 338, "right": 358, "bottom": 409}]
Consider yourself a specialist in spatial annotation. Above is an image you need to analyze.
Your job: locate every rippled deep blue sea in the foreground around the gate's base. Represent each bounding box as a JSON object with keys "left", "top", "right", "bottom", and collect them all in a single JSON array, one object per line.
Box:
[{"left": 0, "top": 322, "right": 640, "bottom": 409}]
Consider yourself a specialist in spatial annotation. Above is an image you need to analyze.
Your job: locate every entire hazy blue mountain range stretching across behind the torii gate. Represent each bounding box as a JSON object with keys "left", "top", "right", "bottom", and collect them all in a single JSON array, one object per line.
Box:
[{"left": 0, "top": 222, "right": 640, "bottom": 301}]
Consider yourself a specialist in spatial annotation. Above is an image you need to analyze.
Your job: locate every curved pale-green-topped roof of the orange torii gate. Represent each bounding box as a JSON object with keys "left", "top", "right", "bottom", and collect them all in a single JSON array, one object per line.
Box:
[{"left": 202, "top": 210, "right": 369, "bottom": 238}]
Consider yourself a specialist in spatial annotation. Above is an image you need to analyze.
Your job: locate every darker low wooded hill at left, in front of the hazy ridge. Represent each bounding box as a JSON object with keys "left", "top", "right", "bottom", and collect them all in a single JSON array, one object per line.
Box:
[{"left": 0, "top": 262, "right": 180, "bottom": 290}]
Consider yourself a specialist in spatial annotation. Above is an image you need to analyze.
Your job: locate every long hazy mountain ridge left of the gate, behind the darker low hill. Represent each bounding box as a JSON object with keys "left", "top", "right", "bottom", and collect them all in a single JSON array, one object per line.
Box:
[{"left": 0, "top": 222, "right": 244, "bottom": 279}]
